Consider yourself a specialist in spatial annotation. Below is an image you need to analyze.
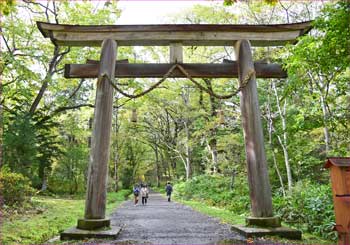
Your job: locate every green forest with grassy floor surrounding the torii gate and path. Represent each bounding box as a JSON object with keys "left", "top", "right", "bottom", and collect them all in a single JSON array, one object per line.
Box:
[{"left": 0, "top": 0, "right": 350, "bottom": 244}]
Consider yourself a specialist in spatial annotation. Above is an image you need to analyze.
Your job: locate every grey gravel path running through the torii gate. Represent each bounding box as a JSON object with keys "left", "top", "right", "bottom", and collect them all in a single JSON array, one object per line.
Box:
[{"left": 108, "top": 193, "right": 245, "bottom": 244}]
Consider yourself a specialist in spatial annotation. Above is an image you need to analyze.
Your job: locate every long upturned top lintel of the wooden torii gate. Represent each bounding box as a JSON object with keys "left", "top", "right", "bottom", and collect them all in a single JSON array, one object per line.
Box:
[{"left": 37, "top": 22, "right": 311, "bottom": 46}]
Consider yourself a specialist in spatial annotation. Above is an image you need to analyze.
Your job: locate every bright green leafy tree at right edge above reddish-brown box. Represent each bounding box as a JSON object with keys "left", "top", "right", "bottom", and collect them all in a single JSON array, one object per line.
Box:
[{"left": 282, "top": 1, "right": 350, "bottom": 156}]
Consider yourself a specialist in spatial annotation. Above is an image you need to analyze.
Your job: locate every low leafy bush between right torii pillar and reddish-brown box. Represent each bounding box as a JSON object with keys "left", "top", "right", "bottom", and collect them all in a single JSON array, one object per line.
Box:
[{"left": 273, "top": 181, "right": 336, "bottom": 240}]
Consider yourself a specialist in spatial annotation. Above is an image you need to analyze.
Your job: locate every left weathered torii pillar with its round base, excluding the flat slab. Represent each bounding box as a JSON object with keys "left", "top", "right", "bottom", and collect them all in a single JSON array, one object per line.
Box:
[{"left": 78, "top": 39, "right": 117, "bottom": 230}]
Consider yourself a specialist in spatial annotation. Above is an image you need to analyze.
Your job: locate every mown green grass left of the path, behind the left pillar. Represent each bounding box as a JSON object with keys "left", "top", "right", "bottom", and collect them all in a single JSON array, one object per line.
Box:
[{"left": 1, "top": 190, "right": 130, "bottom": 244}]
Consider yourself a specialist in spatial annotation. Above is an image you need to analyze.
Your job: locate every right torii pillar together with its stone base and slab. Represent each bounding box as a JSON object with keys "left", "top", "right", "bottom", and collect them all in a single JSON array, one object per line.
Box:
[{"left": 232, "top": 40, "right": 301, "bottom": 239}]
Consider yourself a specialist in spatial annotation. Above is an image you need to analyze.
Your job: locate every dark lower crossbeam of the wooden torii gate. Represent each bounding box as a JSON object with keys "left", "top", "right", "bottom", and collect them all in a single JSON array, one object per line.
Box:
[{"left": 64, "top": 62, "right": 287, "bottom": 78}]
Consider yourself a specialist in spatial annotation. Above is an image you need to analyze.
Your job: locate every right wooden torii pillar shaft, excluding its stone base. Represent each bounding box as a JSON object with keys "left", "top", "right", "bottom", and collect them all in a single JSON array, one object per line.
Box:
[{"left": 235, "top": 40, "right": 273, "bottom": 217}]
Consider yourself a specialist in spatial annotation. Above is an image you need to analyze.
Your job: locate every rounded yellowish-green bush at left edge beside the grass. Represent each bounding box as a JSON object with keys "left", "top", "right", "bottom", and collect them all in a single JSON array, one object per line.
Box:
[{"left": 0, "top": 171, "right": 34, "bottom": 206}]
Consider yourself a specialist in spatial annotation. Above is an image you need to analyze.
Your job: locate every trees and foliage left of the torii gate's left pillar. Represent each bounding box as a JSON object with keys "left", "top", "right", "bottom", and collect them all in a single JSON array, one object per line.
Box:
[{"left": 0, "top": 0, "right": 120, "bottom": 193}]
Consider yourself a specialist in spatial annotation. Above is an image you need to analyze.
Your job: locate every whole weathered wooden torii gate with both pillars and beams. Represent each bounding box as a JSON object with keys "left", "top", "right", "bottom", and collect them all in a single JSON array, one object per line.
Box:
[{"left": 37, "top": 22, "right": 311, "bottom": 238}]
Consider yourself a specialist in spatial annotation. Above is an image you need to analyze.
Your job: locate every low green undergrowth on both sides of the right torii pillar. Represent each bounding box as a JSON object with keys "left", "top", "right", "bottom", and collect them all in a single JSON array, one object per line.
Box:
[{"left": 174, "top": 175, "right": 336, "bottom": 240}]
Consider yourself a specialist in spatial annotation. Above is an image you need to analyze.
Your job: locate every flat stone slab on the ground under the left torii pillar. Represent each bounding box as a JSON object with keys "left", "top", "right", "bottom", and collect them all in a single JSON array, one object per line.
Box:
[{"left": 60, "top": 226, "right": 121, "bottom": 240}]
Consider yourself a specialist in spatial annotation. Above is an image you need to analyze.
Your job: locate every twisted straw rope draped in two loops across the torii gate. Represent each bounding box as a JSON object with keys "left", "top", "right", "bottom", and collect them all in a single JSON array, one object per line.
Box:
[{"left": 103, "top": 64, "right": 255, "bottom": 99}]
